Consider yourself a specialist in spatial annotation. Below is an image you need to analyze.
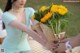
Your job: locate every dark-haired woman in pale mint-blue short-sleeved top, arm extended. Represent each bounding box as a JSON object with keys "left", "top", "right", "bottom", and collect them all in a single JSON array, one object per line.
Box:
[{"left": 2, "top": 0, "right": 54, "bottom": 53}]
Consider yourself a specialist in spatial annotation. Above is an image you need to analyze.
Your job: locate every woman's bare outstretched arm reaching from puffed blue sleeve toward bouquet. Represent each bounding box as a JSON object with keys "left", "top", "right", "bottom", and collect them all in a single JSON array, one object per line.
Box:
[{"left": 9, "top": 20, "right": 54, "bottom": 49}]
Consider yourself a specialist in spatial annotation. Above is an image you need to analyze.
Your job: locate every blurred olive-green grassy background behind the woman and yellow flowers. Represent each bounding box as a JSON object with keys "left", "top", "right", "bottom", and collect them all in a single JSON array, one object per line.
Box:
[{"left": 0, "top": 0, "right": 80, "bottom": 37}]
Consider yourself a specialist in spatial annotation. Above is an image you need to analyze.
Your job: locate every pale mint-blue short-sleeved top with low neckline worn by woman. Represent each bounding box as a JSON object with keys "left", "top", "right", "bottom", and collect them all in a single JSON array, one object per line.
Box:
[{"left": 2, "top": 7, "right": 34, "bottom": 53}]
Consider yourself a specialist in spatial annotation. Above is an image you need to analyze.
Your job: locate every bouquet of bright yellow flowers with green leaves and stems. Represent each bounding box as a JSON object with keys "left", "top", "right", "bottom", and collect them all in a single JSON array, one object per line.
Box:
[{"left": 32, "top": 4, "right": 70, "bottom": 41}]
